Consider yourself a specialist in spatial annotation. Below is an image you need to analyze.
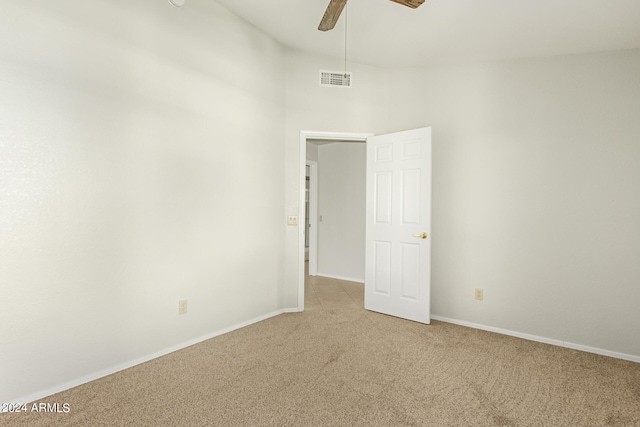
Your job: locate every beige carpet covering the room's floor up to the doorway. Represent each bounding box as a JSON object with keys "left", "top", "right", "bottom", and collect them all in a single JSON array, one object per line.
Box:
[{"left": 0, "top": 308, "right": 640, "bottom": 426}]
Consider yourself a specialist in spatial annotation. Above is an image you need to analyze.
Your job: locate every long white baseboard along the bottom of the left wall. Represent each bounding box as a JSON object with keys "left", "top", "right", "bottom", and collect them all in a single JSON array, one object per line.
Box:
[{"left": 5, "top": 310, "right": 288, "bottom": 406}]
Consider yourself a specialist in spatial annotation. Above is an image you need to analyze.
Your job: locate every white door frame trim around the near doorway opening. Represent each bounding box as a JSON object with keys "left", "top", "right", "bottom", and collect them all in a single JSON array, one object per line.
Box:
[{"left": 298, "top": 130, "right": 373, "bottom": 311}]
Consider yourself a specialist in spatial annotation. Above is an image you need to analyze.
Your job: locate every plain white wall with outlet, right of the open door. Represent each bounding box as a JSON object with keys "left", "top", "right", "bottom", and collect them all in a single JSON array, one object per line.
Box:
[{"left": 389, "top": 50, "right": 640, "bottom": 356}]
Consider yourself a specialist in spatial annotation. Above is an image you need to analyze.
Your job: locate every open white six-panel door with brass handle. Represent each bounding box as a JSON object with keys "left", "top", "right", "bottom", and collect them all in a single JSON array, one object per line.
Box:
[{"left": 364, "top": 128, "right": 431, "bottom": 323}]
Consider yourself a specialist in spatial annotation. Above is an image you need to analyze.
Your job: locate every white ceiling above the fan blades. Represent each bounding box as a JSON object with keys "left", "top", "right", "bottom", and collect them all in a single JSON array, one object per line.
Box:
[{"left": 215, "top": 0, "right": 640, "bottom": 67}]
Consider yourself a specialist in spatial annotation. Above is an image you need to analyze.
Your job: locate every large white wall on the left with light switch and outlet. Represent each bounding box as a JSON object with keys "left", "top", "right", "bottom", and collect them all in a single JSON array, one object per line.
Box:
[{"left": 0, "top": 0, "right": 285, "bottom": 402}]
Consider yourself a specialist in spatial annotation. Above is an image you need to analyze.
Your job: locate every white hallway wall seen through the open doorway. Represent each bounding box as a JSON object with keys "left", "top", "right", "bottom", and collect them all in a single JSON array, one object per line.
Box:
[{"left": 318, "top": 142, "right": 367, "bottom": 283}]
